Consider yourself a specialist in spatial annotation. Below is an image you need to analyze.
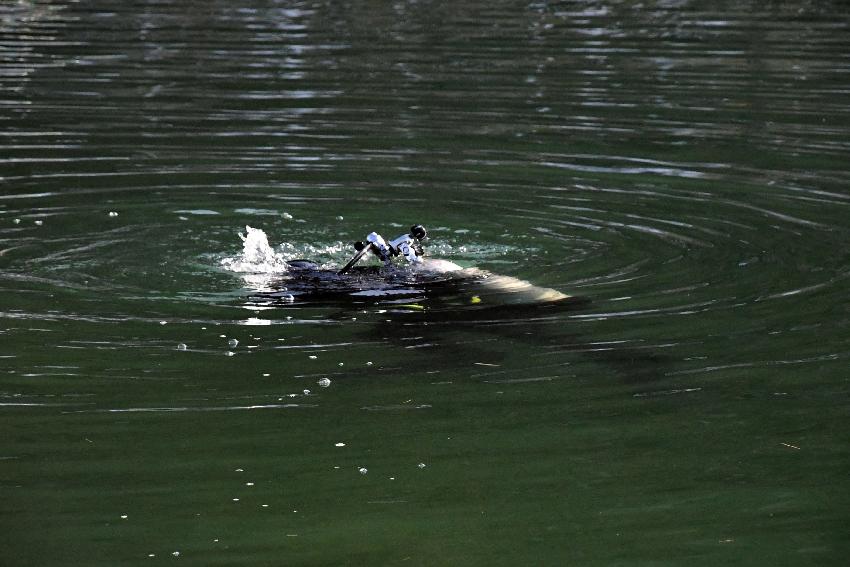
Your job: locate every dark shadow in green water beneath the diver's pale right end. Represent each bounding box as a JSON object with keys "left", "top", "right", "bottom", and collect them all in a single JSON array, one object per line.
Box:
[{"left": 369, "top": 288, "right": 671, "bottom": 387}]
